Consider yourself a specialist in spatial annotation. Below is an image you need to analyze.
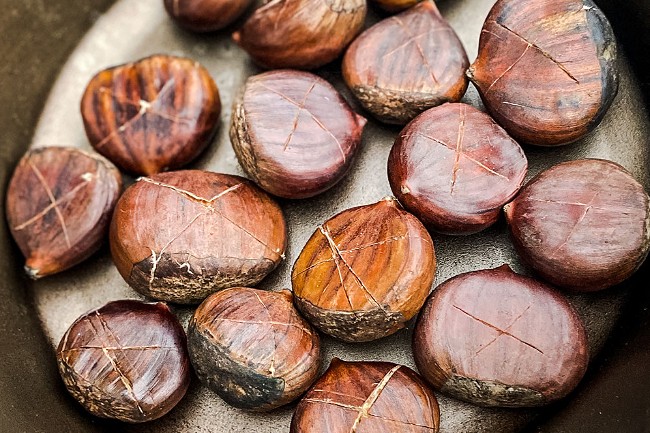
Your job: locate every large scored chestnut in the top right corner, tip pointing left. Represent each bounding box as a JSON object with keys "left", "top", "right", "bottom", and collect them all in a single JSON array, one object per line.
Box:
[{"left": 468, "top": 0, "right": 619, "bottom": 146}]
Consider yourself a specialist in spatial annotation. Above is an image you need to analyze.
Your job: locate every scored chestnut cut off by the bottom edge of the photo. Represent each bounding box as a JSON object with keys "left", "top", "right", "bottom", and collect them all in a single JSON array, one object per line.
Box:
[{"left": 290, "top": 358, "right": 440, "bottom": 433}]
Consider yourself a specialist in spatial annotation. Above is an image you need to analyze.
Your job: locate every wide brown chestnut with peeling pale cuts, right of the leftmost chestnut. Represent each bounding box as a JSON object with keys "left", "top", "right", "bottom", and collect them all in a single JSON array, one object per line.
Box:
[{"left": 110, "top": 170, "right": 287, "bottom": 304}]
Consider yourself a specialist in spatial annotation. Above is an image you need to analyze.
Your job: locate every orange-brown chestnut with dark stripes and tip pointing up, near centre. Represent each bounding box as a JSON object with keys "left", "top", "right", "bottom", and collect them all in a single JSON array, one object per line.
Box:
[{"left": 291, "top": 197, "right": 436, "bottom": 342}]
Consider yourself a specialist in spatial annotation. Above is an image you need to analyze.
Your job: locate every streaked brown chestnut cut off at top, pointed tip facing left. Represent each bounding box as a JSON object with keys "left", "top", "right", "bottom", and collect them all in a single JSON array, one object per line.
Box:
[{"left": 232, "top": 0, "right": 367, "bottom": 69}]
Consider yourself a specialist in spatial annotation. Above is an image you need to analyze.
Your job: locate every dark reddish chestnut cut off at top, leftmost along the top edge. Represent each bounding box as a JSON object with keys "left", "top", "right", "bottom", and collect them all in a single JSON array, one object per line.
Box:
[{"left": 164, "top": 0, "right": 252, "bottom": 32}]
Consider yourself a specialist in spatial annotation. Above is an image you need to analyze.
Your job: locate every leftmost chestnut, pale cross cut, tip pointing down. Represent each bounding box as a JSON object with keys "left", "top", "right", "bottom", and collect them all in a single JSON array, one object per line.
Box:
[{"left": 6, "top": 147, "right": 122, "bottom": 279}]
